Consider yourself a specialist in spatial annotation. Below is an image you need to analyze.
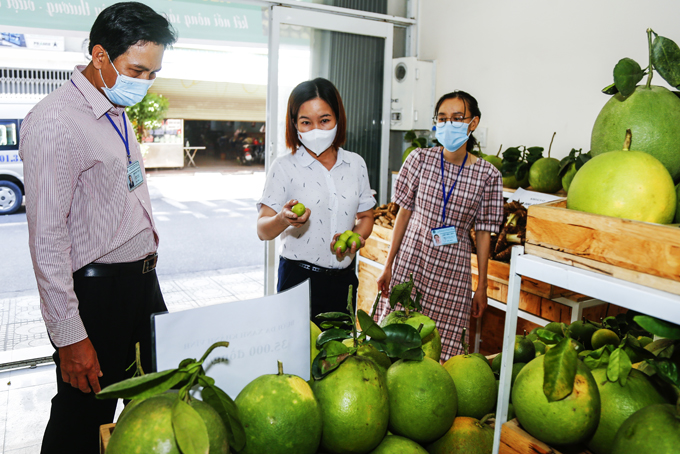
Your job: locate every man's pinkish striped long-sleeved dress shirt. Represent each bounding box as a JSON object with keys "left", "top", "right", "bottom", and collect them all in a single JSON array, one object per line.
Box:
[{"left": 19, "top": 66, "right": 158, "bottom": 347}]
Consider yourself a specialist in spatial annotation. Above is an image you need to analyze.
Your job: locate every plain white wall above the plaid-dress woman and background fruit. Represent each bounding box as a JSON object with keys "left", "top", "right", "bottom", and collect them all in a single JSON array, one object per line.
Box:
[{"left": 418, "top": 0, "right": 680, "bottom": 158}]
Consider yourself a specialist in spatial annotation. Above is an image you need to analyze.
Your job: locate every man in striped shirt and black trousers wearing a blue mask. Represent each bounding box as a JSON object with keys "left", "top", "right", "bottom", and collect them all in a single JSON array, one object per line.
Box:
[{"left": 19, "top": 2, "right": 176, "bottom": 454}]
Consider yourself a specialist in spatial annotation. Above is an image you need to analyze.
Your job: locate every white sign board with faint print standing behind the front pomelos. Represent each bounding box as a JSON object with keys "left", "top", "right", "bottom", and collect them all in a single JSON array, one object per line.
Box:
[{"left": 153, "top": 281, "right": 310, "bottom": 399}]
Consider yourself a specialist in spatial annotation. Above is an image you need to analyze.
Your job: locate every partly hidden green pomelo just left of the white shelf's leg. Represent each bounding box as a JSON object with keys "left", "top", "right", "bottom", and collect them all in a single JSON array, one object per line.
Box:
[{"left": 444, "top": 355, "right": 498, "bottom": 419}]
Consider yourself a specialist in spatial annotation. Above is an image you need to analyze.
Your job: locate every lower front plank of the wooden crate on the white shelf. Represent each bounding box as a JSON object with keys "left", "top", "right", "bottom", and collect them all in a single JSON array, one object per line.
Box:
[{"left": 524, "top": 243, "right": 680, "bottom": 295}]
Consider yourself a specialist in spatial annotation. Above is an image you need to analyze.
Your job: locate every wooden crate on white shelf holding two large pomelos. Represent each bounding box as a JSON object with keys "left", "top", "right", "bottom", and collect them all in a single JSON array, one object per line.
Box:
[{"left": 525, "top": 199, "right": 680, "bottom": 295}]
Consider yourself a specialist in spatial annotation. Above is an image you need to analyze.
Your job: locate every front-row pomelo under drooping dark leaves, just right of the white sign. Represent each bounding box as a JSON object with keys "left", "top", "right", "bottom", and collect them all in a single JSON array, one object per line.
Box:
[{"left": 312, "top": 356, "right": 390, "bottom": 454}]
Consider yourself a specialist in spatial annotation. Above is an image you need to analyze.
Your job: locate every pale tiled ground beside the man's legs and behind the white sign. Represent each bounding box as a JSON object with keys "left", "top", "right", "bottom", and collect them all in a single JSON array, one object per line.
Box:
[{"left": 0, "top": 267, "right": 264, "bottom": 454}]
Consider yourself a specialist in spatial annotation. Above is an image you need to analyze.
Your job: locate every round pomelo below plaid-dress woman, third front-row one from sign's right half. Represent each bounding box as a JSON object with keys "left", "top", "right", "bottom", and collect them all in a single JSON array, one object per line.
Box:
[{"left": 386, "top": 357, "right": 458, "bottom": 444}]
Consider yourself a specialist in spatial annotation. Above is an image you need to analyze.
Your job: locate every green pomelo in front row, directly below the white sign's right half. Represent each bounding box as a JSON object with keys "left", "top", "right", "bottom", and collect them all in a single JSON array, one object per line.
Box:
[{"left": 235, "top": 365, "right": 322, "bottom": 454}]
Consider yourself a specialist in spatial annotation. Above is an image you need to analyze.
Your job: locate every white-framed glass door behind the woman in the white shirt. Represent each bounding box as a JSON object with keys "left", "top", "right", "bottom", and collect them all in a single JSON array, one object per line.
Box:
[{"left": 265, "top": 6, "right": 393, "bottom": 295}]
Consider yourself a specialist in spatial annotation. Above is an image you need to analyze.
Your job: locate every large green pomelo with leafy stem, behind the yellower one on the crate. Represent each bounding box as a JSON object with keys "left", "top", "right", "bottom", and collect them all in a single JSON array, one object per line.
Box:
[{"left": 579, "top": 85, "right": 680, "bottom": 181}]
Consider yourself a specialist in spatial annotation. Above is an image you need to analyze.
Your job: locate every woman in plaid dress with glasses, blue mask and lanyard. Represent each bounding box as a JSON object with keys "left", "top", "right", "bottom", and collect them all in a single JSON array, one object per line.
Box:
[{"left": 376, "top": 91, "right": 503, "bottom": 361}]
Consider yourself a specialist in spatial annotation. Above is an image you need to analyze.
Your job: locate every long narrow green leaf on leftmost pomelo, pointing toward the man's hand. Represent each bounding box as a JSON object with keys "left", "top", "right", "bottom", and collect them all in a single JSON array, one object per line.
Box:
[{"left": 97, "top": 369, "right": 187, "bottom": 399}]
